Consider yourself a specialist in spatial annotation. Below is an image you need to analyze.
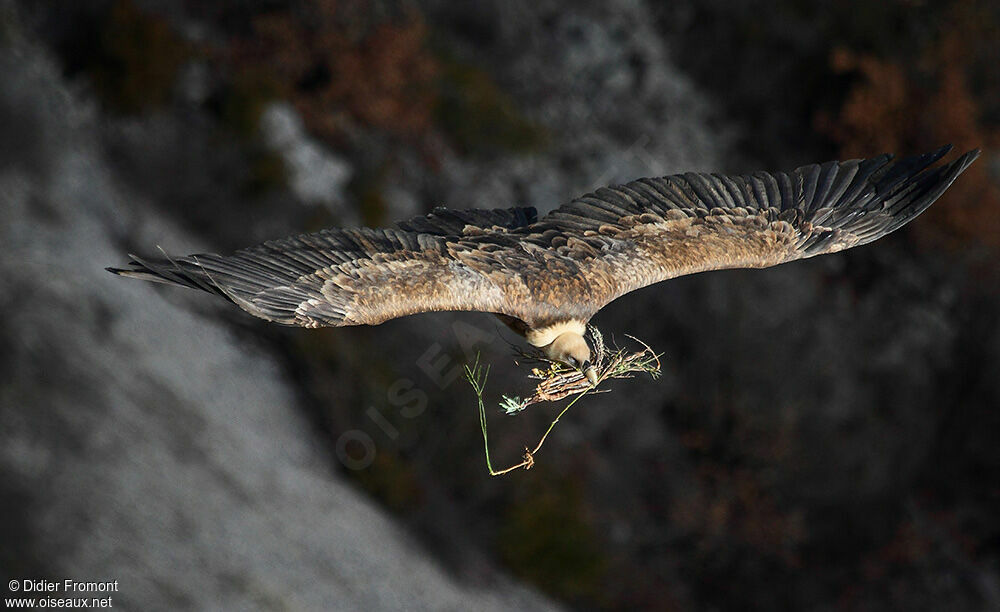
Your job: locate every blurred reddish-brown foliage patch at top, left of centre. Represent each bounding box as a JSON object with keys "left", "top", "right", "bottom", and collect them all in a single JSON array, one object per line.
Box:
[{"left": 229, "top": 0, "right": 438, "bottom": 139}]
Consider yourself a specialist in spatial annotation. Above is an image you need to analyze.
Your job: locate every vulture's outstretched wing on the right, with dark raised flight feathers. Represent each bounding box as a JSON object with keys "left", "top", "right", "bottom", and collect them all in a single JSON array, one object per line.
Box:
[{"left": 521, "top": 146, "right": 979, "bottom": 313}]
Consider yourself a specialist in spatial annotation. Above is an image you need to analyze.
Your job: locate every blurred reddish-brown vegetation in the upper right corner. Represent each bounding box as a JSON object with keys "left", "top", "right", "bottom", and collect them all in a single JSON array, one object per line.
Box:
[{"left": 817, "top": 10, "right": 1000, "bottom": 247}]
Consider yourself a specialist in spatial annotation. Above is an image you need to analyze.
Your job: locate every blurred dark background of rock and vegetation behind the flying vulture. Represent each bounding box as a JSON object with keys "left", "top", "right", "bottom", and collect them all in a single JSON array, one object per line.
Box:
[{"left": 0, "top": 0, "right": 1000, "bottom": 610}]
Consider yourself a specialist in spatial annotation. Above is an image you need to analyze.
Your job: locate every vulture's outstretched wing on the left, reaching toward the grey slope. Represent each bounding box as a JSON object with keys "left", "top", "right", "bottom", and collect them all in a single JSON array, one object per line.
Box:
[{"left": 108, "top": 208, "right": 536, "bottom": 327}]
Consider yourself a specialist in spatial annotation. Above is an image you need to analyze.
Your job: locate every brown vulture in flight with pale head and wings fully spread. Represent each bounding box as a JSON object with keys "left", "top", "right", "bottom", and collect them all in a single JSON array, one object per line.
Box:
[{"left": 108, "top": 146, "right": 979, "bottom": 383}]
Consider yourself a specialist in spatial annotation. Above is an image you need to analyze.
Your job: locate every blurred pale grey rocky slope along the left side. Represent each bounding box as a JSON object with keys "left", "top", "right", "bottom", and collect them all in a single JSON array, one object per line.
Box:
[{"left": 0, "top": 21, "right": 551, "bottom": 610}]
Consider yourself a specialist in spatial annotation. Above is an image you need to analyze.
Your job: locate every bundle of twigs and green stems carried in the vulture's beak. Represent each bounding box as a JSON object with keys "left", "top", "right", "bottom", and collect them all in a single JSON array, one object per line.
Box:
[{"left": 465, "top": 326, "right": 660, "bottom": 476}]
